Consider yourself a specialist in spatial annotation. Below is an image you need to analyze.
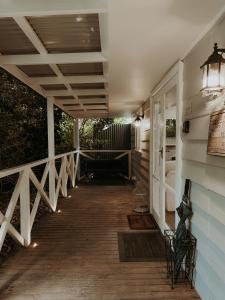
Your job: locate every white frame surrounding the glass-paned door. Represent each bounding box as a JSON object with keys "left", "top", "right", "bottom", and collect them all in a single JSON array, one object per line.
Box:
[{"left": 149, "top": 61, "right": 183, "bottom": 232}]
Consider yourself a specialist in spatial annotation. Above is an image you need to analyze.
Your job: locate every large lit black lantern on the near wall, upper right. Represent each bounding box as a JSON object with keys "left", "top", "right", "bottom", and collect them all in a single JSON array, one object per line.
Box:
[{"left": 201, "top": 43, "right": 225, "bottom": 96}]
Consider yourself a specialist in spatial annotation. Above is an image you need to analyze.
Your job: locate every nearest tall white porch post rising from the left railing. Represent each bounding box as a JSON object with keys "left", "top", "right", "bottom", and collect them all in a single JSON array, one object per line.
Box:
[{"left": 47, "top": 99, "right": 56, "bottom": 210}]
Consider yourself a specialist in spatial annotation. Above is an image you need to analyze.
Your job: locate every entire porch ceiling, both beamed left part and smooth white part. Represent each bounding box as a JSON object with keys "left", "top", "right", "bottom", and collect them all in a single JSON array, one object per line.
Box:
[{"left": 0, "top": 0, "right": 224, "bottom": 117}]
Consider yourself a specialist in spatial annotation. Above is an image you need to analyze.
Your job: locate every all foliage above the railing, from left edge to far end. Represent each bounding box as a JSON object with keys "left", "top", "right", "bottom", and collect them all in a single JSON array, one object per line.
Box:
[{"left": 0, "top": 65, "right": 130, "bottom": 169}]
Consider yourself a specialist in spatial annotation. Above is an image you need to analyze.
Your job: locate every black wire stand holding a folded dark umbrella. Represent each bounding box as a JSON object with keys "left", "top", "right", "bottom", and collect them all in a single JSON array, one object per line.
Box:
[{"left": 164, "top": 179, "right": 197, "bottom": 288}]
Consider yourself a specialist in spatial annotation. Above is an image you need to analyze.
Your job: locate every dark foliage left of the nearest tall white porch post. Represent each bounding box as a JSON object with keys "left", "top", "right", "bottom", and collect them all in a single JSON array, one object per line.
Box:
[{"left": 0, "top": 69, "right": 47, "bottom": 169}]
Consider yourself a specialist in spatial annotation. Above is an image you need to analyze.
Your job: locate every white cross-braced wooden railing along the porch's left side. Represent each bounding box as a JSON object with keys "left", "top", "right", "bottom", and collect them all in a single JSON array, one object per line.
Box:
[{"left": 0, "top": 151, "right": 79, "bottom": 251}]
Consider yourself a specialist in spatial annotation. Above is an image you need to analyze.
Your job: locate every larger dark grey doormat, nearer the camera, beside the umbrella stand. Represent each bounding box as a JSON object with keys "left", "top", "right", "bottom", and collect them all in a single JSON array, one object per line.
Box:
[{"left": 118, "top": 230, "right": 166, "bottom": 262}]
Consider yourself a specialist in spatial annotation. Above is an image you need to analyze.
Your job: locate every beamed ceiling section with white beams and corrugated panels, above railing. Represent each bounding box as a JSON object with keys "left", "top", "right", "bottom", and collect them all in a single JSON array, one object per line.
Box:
[{"left": 0, "top": 0, "right": 108, "bottom": 117}]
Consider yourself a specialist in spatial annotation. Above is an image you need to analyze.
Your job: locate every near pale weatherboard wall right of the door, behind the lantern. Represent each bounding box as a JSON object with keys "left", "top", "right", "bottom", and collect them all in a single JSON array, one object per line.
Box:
[{"left": 182, "top": 13, "right": 225, "bottom": 300}]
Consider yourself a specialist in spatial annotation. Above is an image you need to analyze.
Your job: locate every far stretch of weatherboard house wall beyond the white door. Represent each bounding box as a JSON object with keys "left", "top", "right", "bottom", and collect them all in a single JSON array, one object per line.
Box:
[{"left": 131, "top": 100, "right": 150, "bottom": 204}]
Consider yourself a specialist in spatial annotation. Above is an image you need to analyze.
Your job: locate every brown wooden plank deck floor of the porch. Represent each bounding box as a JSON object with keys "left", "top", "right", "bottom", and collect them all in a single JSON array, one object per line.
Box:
[{"left": 0, "top": 186, "right": 198, "bottom": 300}]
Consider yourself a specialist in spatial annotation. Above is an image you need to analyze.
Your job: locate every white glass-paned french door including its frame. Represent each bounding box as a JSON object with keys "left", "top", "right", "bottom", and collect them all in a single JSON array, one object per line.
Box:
[{"left": 150, "top": 63, "right": 182, "bottom": 231}]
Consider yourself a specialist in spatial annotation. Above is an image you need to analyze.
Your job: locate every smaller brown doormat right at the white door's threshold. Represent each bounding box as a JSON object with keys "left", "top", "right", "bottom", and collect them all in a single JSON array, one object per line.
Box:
[{"left": 127, "top": 215, "right": 158, "bottom": 230}]
